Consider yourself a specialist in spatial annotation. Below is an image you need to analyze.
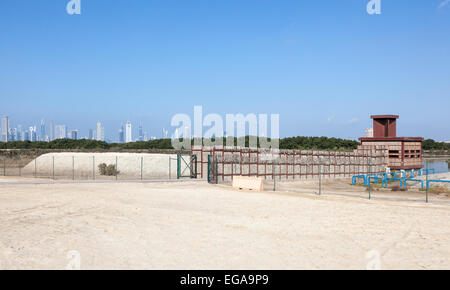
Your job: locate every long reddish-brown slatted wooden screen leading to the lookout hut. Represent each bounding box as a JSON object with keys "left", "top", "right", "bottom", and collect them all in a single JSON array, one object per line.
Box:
[{"left": 191, "top": 146, "right": 388, "bottom": 181}]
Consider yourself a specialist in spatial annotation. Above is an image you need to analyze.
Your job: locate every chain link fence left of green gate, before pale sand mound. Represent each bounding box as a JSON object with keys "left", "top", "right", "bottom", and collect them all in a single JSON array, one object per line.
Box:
[{"left": 0, "top": 153, "right": 182, "bottom": 180}]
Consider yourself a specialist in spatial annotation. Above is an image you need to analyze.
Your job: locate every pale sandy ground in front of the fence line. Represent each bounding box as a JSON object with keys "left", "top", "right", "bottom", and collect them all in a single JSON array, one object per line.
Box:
[{"left": 0, "top": 178, "right": 450, "bottom": 269}]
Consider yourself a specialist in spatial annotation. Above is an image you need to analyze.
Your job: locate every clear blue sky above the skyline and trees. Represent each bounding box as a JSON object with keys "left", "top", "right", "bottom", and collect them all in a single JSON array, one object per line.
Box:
[{"left": 0, "top": 0, "right": 450, "bottom": 140}]
